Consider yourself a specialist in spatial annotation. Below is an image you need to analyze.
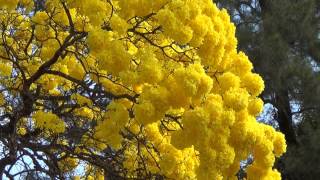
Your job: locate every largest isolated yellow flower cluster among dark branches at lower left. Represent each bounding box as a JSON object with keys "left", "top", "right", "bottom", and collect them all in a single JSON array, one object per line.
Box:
[{"left": 32, "top": 111, "right": 66, "bottom": 133}]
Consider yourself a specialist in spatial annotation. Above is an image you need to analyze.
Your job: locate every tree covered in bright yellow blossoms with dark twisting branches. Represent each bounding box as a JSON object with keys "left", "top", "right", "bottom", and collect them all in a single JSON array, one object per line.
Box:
[{"left": 0, "top": 0, "right": 286, "bottom": 180}]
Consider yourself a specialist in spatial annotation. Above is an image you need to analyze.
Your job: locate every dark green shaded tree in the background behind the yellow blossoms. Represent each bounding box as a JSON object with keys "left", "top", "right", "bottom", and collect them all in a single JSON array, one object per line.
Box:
[{"left": 218, "top": 0, "right": 320, "bottom": 179}]
